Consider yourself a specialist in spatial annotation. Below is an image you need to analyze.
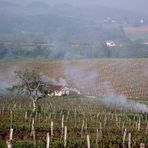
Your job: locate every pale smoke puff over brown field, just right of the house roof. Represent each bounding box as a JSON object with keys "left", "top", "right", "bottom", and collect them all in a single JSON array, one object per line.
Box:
[{"left": 64, "top": 64, "right": 98, "bottom": 93}]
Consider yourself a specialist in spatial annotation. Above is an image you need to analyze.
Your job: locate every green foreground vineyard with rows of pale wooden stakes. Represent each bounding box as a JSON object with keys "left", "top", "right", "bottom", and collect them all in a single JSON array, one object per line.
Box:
[{"left": 0, "top": 96, "right": 148, "bottom": 148}]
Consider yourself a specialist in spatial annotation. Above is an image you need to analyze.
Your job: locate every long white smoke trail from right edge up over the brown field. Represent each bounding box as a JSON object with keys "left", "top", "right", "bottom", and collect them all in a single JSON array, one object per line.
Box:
[{"left": 64, "top": 62, "right": 148, "bottom": 113}]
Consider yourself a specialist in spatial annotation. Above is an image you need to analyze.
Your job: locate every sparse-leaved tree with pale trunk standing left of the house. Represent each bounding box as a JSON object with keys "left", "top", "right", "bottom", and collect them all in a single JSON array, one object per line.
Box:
[{"left": 8, "top": 68, "right": 49, "bottom": 146}]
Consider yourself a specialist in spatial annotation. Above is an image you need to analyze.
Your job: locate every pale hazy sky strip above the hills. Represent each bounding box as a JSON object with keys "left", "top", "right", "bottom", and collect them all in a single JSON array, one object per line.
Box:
[{"left": 0, "top": 0, "right": 148, "bottom": 12}]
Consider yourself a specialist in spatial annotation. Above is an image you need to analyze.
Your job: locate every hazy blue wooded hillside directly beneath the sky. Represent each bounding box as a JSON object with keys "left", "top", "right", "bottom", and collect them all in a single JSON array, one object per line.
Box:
[{"left": 0, "top": 1, "right": 140, "bottom": 44}]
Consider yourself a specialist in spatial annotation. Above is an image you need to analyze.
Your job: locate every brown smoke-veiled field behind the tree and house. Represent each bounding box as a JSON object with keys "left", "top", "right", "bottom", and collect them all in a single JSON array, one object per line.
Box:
[{"left": 0, "top": 59, "right": 148, "bottom": 99}]
